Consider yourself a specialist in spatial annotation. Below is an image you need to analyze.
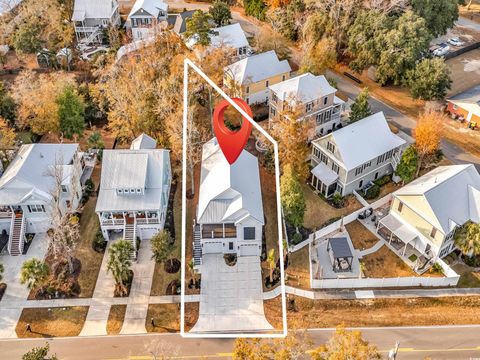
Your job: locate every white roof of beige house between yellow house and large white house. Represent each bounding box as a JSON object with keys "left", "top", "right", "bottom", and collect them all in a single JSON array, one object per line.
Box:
[{"left": 269, "top": 73, "right": 337, "bottom": 103}]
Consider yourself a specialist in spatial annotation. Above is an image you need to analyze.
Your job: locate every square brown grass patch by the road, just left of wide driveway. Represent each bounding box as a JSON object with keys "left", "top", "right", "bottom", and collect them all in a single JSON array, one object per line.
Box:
[{"left": 145, "top": 304, "right": 180, "bottom": 333}]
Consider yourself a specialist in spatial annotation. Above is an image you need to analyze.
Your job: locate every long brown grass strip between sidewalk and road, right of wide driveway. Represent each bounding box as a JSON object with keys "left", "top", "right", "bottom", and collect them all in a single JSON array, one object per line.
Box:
[{"left": 264, "top": 296, "right": 480, "bottom": 329}]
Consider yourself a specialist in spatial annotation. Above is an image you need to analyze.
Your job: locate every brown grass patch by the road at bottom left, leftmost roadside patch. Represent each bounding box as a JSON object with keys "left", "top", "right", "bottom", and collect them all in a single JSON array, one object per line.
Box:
[{"left": 15, "top": 306, "right": 88, "bottom": 338}]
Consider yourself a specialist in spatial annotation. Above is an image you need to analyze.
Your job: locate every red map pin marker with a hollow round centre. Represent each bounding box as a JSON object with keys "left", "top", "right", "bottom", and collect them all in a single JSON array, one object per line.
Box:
[{"left": 213, "top": 98, "right": 252, "bottom": 165}]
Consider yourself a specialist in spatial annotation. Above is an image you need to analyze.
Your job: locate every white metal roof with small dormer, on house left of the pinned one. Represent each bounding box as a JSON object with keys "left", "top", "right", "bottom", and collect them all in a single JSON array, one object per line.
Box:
[{"left": 95, "top": 149, "right": 170, "bottom": 212}]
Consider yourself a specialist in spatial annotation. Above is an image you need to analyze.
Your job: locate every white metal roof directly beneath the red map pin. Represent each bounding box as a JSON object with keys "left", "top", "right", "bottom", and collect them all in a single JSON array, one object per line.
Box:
[{"left": 197, "top": 138, "right": 264, "bottom": 224}]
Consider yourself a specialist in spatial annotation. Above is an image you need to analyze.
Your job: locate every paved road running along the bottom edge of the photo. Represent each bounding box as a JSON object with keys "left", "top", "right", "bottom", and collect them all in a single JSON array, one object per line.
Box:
[{"left": 0, "top": 326, "right": 480, "bottom": 360}]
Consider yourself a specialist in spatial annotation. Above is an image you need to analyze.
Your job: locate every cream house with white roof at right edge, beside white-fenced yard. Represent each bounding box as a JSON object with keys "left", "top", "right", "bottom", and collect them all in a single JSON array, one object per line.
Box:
[{"left": 377, "top": 164, "right": 480, "bottom": 271}]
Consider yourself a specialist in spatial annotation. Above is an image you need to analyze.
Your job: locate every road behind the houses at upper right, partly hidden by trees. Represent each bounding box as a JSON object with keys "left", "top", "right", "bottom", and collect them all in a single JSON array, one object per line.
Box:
[{"left": 327, "top": 71, "right": 480, "bottom": 171}]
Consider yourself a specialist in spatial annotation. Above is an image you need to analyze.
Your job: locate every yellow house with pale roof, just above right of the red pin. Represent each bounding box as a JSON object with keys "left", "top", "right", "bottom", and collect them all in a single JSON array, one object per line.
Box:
[{"left": 223, "top": 50, "right": 292, "bottom": 104}]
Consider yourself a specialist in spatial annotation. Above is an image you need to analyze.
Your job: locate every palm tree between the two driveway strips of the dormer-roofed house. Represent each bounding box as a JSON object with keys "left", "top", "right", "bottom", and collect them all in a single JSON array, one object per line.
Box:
[{"left": 107, "top": 239, "right": 133, "bottom": 295}]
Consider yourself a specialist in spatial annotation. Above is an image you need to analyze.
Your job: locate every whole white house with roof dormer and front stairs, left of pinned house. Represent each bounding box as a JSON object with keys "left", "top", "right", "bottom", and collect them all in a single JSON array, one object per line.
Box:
[{"left": 95, "top": 136, "right": 172, "bottom": 256}]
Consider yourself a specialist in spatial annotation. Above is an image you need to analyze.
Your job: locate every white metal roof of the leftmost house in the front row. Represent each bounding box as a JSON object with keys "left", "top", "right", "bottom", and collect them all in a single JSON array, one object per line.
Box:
[{"left": 0, "top": 144, "right": 78, "bottom": 205}]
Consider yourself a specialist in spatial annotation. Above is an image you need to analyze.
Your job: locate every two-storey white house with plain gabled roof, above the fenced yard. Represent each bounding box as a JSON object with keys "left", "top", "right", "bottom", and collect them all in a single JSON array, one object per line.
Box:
[{"left": 311, "top": 112, "right": 406, "bottom": 197}]
